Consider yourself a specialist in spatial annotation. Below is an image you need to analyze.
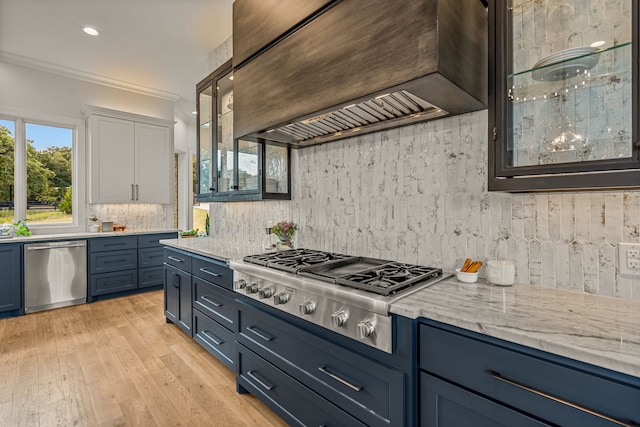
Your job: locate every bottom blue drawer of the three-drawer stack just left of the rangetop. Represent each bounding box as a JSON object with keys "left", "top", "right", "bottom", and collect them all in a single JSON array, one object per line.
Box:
[{"left": 193, "top": 309, "right": 237, "bottom": 372}]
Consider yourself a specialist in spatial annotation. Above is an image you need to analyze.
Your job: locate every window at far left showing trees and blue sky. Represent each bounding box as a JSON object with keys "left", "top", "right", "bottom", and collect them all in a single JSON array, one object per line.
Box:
[{"left": 0, "top": 113, "right": 79, "bottom": 227}]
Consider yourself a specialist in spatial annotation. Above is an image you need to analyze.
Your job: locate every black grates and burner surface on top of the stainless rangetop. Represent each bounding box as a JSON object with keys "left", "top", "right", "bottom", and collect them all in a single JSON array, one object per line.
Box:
[{"left": 244, "top": 249, "right": 442, "bottom": 296}]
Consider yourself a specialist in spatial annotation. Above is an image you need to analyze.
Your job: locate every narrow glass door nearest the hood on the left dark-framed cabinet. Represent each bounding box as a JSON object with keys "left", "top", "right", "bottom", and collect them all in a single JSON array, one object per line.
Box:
[{"left": 216, "top": 71, "right": 236, "bottom": 193}]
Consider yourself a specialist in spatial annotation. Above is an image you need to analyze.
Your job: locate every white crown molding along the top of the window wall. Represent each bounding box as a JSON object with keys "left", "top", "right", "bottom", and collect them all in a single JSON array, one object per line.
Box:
[{"left": 0, "top": 51, "right": 180, "bottom": 102}]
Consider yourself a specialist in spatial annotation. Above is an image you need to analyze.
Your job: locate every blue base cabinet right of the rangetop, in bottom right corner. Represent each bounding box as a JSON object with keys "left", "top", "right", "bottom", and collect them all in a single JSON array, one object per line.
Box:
[{"left": 418, "top": 321, "right": 640, "bottom": 427}]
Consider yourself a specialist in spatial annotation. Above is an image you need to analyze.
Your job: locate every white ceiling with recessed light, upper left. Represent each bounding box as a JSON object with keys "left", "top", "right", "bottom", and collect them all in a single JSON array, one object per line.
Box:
[{"left": 0, "top": 0, "right": 233, "bottom": 115}]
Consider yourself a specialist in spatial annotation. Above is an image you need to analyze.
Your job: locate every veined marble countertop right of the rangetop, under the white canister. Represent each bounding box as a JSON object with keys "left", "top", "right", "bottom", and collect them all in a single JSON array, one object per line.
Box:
[{"left": 390, "top": 278, "right": 640, "bottom": 377}]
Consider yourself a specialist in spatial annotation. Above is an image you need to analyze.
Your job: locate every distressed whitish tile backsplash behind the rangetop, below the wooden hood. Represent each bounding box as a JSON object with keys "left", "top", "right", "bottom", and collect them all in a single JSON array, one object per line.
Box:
[{"left": 211, "top": 110, "right": 640, "bottom": 299}]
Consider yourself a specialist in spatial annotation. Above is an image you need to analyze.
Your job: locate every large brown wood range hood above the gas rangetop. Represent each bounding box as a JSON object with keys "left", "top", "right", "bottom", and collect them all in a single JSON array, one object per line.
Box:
[{"left": 234, "top": 0, "right": 487, "bottom": 147}]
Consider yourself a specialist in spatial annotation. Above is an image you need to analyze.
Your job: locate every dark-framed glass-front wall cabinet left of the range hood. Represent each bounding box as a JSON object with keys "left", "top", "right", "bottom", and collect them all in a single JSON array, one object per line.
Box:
[{"left": 196, "top": 61, "right": 291, "bottom": 202}]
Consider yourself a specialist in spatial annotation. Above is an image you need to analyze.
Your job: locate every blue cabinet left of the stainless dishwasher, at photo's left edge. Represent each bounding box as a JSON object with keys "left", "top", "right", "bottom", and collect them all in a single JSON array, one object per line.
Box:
[{"left": 0, "top": 244, "right": 23, "bottom": 318}]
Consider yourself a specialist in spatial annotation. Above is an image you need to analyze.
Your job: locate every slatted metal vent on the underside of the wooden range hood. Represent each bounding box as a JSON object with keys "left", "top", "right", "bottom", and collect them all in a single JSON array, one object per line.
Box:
[{"left": 258, "top": 90, "right": 448, "bottom": 146}]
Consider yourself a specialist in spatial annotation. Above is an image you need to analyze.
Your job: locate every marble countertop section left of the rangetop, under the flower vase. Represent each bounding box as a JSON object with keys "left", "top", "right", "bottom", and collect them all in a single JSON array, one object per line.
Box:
[{"left": 160, "top": 237, "right": 267, "bottom": 263}]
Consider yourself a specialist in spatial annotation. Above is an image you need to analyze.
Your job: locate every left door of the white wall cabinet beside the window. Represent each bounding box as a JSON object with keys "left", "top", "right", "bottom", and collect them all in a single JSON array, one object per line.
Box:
[{"left": 89, "top": 116, "right": 135, "bottom": 203}]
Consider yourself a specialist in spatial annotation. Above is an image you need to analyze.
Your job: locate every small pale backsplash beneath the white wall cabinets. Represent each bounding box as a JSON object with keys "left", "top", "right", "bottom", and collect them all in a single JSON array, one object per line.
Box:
[{"left": 87, "top": 203, "right": 173, "bottom": 229}]
